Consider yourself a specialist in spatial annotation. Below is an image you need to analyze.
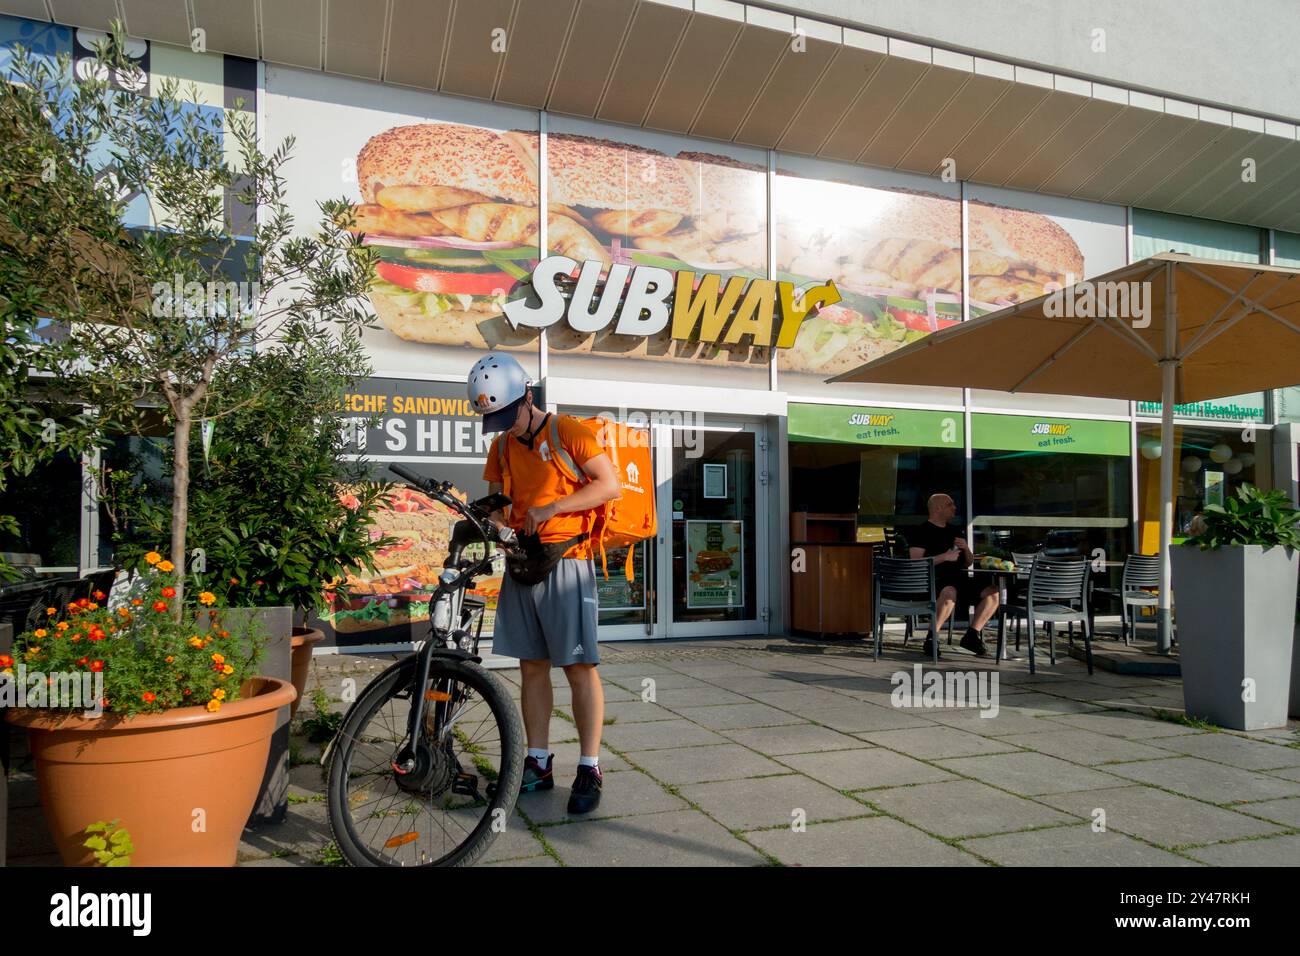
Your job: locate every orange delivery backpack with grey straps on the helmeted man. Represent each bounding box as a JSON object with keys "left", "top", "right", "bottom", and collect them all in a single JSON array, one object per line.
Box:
[{"left": 497, "top": 415, "right": 659, "bottom": 581}]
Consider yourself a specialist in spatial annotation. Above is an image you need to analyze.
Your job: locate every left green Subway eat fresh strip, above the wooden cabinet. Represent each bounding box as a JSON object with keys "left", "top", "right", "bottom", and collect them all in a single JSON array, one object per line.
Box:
[{"left": 789, "top": 403, "right": 966, "bottom": 449}]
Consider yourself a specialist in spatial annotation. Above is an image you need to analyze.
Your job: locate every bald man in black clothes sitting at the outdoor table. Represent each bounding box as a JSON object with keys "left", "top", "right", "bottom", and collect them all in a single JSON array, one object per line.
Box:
[{"left": 907, "top": 494, "right": 1001, "bottom": 657}]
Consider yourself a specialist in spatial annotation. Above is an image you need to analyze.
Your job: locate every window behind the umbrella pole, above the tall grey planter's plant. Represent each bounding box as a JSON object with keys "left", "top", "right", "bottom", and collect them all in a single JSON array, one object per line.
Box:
[{"left": 1138, "top": 424, "right": 1273, "bottom": 554}]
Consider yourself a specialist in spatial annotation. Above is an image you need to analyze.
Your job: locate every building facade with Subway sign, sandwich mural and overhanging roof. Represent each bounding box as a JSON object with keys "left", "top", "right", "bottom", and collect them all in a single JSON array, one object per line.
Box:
[{"left": 0, "top": 0, "right": 1300, "bottom": 648}]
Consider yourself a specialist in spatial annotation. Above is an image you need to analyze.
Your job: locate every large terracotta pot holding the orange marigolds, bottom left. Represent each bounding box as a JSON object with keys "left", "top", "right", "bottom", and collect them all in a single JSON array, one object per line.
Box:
[{"left": 8, "top": 678, "right": 294, "bottom": 866}]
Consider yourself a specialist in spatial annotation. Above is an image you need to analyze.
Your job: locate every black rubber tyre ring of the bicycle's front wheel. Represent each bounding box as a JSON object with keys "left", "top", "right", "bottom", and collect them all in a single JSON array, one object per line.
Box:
[{"left": 326, "top": 656, "right": 524, "bottom": 866}]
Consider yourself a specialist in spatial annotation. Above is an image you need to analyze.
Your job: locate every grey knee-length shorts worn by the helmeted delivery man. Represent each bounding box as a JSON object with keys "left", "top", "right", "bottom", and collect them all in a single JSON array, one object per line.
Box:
[{"left": 491, "top": 558, "right": 601, "bottom": 667}]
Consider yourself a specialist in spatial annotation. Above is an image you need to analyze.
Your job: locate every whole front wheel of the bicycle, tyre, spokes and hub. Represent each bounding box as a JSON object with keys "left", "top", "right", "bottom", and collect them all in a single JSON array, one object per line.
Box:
[{"left": 328, "top": 657, "right": 524, "bottom": 866}]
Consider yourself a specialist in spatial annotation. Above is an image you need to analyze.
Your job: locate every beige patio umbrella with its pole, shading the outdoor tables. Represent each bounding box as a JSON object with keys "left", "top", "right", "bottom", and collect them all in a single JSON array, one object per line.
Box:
[{"left": 829, "top": 252, "right": 1300, "bottom": 653}]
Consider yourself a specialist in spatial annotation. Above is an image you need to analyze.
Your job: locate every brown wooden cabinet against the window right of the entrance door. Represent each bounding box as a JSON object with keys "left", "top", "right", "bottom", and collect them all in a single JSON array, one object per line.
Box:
[{"left": 790, "top": 541, "right": 872, "bottom": 635}]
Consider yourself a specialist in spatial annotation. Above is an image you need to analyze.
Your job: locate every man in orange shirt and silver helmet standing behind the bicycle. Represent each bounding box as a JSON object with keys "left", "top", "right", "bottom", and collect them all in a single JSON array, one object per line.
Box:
[{"left": 469, "top": 352, "right": 621, "bottom": 814}]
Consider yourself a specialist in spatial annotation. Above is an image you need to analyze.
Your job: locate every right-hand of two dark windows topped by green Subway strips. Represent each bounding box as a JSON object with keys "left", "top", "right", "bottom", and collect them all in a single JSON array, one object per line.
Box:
[{"left": 971, "top": 415, "right": 1131, "bottom": 561}]
